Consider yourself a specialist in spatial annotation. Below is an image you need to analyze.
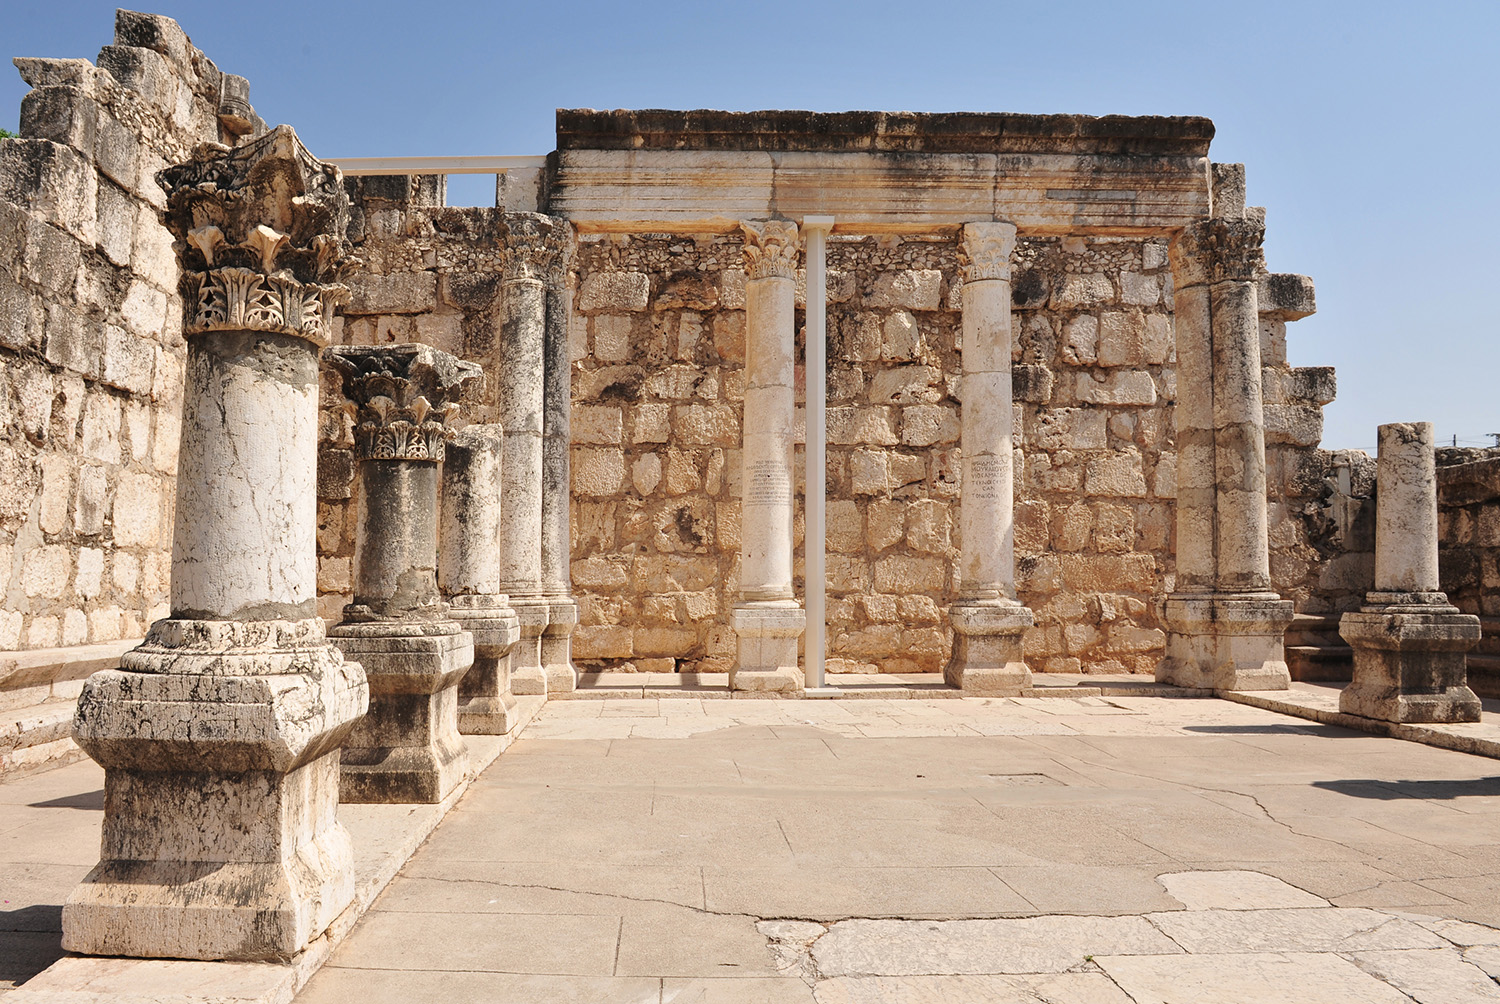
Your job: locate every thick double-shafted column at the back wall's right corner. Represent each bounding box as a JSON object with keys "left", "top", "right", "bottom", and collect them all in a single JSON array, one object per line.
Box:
[{"left": 1157, "top": 219, "right": 1292, "bottom": 690}]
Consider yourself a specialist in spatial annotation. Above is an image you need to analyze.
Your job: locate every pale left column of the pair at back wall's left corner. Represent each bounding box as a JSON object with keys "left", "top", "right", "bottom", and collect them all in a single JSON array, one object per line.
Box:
[{"left": 495, "top": 213, "right": 563, "bottom": 693}]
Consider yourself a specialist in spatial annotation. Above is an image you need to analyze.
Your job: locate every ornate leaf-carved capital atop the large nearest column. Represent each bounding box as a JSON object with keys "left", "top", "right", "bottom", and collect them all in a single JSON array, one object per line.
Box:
[{"left": 156, "top": 126, "right": 359, "bottom": 345}]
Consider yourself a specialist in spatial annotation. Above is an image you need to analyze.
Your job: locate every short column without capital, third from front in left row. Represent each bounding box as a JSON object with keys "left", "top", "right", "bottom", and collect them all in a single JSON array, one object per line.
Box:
[{"left": 438, "top": 425, "right": 521, "bottom": 735}]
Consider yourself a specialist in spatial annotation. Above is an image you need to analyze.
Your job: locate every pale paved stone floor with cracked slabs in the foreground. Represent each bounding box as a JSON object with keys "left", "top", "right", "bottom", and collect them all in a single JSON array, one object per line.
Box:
[{"left": 0, "top": 698, "right": 1500, "bottom": 1004}]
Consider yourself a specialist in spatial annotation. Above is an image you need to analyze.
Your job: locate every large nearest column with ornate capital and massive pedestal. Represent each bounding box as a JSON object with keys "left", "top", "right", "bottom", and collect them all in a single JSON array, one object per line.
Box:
[{"left": 63, "top": 126, "right": 369, "bottom": 959}]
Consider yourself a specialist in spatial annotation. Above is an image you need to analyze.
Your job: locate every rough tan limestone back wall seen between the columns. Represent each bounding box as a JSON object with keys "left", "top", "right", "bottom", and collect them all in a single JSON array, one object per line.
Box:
[{"left": 320, "top": 196, "right": 1334, "bottom": 672}]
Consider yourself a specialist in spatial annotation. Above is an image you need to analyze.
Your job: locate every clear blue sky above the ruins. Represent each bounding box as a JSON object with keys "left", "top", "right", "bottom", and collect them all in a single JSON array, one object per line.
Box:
[{"left": 0, "top": 0, "right": 1500, "bottom": 450}]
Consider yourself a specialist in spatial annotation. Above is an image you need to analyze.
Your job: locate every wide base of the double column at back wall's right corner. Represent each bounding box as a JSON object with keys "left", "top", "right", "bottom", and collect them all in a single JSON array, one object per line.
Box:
[{"left": 1157, "top": 593, "right": 1293, "bottom": 690}]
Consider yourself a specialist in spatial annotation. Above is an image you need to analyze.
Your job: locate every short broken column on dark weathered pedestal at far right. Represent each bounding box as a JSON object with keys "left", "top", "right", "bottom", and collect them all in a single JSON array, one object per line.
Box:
[{"left": 1338, "top": 422, "right": 1479, "bottom": 722}]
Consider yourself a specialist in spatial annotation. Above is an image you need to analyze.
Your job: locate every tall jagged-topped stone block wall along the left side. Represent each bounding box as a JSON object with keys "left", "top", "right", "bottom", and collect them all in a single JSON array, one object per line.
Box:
[{"left": 0, "top": 11, "right": 263, "bottom": 650}]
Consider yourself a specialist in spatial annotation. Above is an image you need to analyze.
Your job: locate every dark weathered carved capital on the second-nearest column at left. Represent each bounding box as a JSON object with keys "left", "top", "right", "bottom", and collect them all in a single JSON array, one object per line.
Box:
[{"left": 323, "top": 344, "right": 485, "bottom": 464}]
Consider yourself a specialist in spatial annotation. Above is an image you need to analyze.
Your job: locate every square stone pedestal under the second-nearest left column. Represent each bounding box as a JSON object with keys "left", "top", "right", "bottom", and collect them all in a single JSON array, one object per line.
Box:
[{"left": 329, "top": 620, "right": 474, "bottom": 803}]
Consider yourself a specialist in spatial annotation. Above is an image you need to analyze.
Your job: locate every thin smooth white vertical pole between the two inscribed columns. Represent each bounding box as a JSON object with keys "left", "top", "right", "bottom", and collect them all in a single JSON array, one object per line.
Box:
[{"left": 803, "top": 216, "right": 834, "bottom": 690}]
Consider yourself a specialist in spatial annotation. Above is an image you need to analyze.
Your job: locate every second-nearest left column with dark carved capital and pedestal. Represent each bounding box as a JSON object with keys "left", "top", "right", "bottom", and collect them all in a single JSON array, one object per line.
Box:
[{"left": 326, "top": 344, "right": 483, "bottom": 803}]
